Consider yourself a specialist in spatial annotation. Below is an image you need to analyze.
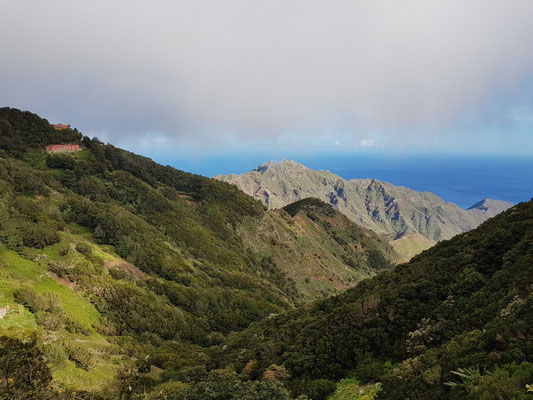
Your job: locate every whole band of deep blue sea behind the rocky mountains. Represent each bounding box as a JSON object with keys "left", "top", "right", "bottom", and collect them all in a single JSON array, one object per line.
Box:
[{"left": 156, "top": 152, "right": 533, "bottom": 208}]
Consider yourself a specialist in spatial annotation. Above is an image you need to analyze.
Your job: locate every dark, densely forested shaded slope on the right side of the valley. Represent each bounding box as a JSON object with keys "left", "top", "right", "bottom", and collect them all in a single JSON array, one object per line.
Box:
[{"left": 221, "top": 199, "right": 533, "bottom": 400}]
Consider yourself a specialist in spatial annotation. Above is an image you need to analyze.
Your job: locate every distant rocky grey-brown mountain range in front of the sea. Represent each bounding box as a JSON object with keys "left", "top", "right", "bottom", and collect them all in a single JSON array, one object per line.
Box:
[{"left": 215, "top": 160, "right": 512, "bottom": 260}]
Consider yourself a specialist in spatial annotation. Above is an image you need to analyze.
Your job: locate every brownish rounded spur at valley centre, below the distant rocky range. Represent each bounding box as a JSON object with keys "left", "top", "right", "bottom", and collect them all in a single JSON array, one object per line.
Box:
[{"left": 239, "top": 198, "right": 398, "bottom": 301}]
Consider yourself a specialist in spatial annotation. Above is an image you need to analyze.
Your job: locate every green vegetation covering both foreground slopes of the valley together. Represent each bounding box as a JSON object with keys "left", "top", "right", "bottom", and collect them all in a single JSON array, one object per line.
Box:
[{"left": 0, "top": 109, "right": 533, "bottom": 400}]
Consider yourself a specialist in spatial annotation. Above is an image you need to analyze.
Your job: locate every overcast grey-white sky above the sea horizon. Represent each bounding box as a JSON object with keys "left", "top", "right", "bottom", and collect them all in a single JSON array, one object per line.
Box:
[{"left": 0, "top": 0, "right": 533, "bottom": 155}]
